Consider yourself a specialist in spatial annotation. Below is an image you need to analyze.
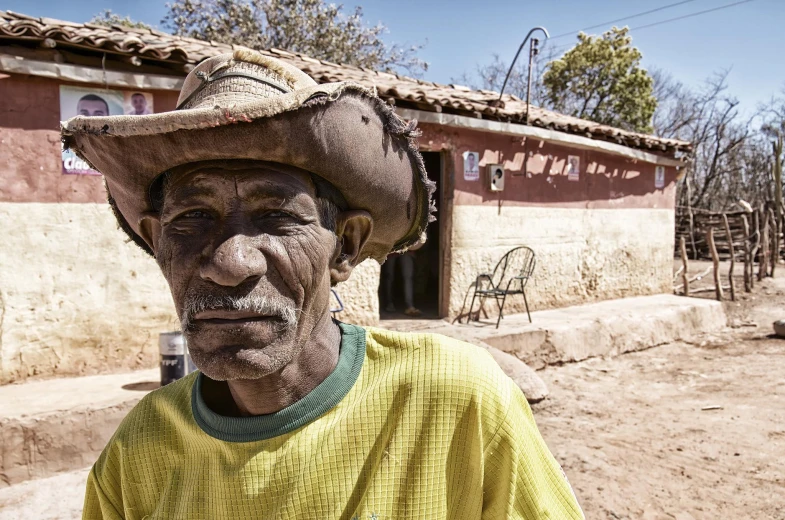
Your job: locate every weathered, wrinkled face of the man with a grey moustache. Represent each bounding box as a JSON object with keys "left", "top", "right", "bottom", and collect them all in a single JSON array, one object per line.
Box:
[{"left": 156, "top": 166, "right": 338, "bottom": 380}]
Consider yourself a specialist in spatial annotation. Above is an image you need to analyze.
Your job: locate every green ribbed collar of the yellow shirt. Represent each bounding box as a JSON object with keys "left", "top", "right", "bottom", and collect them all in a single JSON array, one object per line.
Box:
[{"left": 191, "top": 323, "right": 365, "bottom": 442}]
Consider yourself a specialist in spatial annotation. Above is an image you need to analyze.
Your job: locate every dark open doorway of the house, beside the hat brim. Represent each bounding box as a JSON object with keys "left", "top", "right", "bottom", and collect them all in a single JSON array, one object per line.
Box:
[{"left": 379, "top": 152, "right": 442, "bottom": 319}]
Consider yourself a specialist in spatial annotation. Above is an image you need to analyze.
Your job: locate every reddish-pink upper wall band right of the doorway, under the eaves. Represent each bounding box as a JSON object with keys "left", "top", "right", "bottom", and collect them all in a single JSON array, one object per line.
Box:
[{"left": 420, "top": 124, "right": 678, "bottom": 209}]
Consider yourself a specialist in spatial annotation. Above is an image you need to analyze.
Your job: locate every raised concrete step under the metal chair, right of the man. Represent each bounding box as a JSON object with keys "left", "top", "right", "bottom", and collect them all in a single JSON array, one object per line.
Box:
[{"left": 382, "top": 294, "right": 727, "bottom": 369}]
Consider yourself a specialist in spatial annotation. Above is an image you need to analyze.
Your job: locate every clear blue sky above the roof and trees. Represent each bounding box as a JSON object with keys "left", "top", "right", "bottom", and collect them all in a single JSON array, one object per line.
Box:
[{"left": 7, "top": 0, "right": 785, "bottom": 112}]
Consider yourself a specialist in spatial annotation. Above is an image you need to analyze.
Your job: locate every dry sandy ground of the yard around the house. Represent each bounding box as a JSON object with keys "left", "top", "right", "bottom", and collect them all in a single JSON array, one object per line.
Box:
[{"left": 0, "top": 264, "right": 785, "bottom": 520}]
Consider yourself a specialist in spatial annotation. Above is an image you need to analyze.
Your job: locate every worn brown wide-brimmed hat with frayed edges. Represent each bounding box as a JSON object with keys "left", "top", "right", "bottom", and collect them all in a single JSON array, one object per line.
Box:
[{"left": 61, "top": 50, "right": 434, "bottom": 261}]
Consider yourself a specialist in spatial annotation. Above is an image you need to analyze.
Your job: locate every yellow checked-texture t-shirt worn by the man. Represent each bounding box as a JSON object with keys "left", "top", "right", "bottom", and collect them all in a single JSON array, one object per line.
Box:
[{"left": 84, "top": 324, "right": 583, "bottom": 520}]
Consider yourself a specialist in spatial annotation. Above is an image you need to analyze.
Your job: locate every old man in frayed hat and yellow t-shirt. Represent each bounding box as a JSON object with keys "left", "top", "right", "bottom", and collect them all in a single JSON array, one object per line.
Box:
[{"left": 63, "top": 51, "right": 582, "bottom": 520}]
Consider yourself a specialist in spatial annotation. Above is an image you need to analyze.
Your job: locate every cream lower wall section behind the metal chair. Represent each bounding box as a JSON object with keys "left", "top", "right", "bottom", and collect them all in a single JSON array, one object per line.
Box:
[{"left": 450, "top": 205, "right": 674, "bottom": 317}]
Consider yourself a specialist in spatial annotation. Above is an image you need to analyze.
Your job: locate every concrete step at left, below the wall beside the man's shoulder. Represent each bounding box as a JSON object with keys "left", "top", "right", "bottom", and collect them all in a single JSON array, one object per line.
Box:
[{"left": 0, "top": 369, "right": 160, "bottom": 487}]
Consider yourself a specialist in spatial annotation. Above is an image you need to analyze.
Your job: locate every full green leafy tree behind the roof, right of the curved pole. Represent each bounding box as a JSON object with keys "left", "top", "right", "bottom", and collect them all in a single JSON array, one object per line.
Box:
[{"left": 543, "top": 27, "right": 657, "bottom": 132}]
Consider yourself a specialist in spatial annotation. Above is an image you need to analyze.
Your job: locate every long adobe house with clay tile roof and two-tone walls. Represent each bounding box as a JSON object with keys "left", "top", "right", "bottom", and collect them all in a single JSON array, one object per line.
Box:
[{"left": 0, "top": 11, "right": 690, "bottom": 384}]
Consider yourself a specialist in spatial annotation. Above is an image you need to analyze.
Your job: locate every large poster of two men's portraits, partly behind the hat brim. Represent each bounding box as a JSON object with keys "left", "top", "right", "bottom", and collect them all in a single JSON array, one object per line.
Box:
[{"left": 60, "top": 85, "right": 153, "bottom": 175}]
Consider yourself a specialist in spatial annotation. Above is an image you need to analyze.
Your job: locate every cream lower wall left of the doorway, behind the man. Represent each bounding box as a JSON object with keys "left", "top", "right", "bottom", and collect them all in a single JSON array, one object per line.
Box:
[{"left": 0, "top": 203, "right": 380, "bottom": 384}]
